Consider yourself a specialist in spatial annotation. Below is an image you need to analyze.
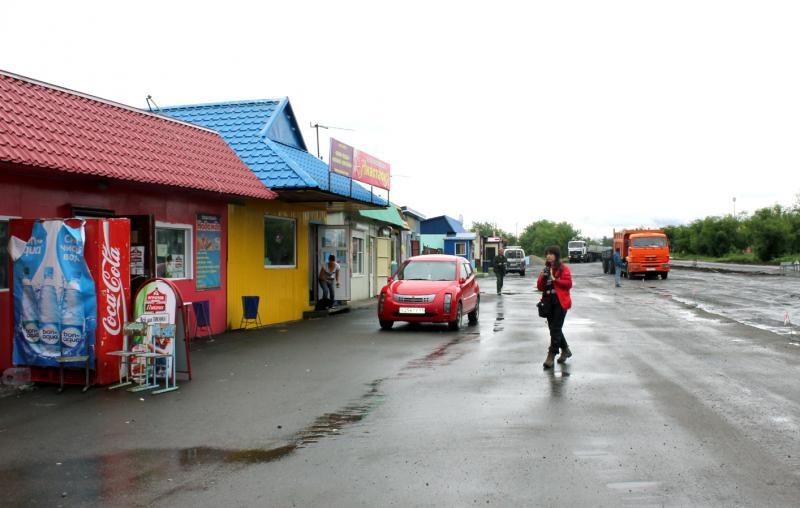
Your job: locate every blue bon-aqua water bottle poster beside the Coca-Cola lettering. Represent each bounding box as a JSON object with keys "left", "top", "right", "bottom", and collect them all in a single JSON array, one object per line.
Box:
[{"left": 12, "top": 220, "right": 97, "bottom": 367}]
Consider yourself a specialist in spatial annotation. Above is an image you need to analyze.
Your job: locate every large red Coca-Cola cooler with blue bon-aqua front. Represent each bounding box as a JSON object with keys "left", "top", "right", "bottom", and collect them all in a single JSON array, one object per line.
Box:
[{"left": 7, "top": 219, "right": 130, "bottom": 387}]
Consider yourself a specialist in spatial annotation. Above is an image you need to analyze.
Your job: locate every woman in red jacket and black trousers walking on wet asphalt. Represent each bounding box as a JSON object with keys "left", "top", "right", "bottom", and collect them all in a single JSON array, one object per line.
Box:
[{"left": 536, "top": 245, "right": 572, "bottom": 369}]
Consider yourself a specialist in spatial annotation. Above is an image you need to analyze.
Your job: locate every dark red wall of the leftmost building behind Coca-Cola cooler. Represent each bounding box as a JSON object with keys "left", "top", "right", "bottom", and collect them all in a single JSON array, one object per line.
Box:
[{"left": 0, "top": 163, "right": 228, "bottom": 366}]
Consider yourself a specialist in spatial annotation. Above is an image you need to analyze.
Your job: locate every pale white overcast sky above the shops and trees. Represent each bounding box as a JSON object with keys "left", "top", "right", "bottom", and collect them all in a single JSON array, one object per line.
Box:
[{"left": 0, "top": 0, "right": 800, "bottom": 237}]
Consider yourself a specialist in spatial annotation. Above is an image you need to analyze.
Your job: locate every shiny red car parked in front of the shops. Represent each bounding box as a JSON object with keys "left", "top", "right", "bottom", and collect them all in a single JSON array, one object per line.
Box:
[{"left": 378, "top": 255, "right": 480, "bottom": 330}]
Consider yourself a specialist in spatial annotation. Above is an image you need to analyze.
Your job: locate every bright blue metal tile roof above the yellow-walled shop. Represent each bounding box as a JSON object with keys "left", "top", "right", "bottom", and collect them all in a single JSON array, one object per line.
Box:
[{"left": 161, "top": 98, "right": 386, "bottom": 206}]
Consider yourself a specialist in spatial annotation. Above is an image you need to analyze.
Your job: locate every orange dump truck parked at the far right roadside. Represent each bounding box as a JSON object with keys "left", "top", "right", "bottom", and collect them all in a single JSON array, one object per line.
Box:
[{"left": 614, "top": 229, "right": 669, "bottom": 279}]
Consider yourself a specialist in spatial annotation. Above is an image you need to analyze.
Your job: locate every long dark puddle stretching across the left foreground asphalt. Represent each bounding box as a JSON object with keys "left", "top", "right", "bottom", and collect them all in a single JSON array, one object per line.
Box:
[{"left": 0, "top": 379, "right": 385, "bottom": 505}]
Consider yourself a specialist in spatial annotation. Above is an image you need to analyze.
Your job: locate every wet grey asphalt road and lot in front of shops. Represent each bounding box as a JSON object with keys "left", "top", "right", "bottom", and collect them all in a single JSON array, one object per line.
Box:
[{"left": 0, "top": 263, "right": 800, "bottom": 507}]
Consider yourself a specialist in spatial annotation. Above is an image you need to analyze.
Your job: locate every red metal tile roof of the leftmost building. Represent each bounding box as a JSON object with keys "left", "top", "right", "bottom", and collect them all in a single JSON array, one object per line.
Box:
[{"left": 0, "top": 71, "right": 277, "bottom": 199}]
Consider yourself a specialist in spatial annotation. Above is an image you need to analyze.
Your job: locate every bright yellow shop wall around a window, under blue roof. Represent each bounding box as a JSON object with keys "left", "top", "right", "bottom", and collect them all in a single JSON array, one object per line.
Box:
[{"left": 228, "top": 200, "right": 326, "bottom": 329}]
